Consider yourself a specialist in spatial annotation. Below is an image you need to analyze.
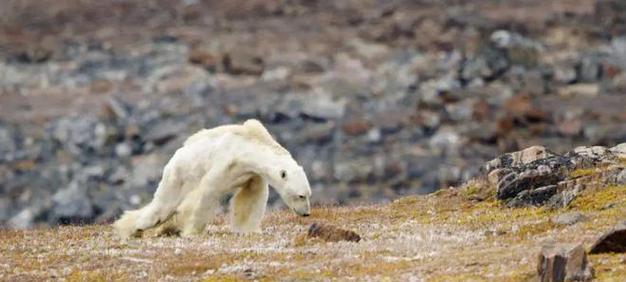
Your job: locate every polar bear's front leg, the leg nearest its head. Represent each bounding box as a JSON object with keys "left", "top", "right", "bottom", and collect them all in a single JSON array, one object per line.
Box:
[{"left": 230, "top": 176, "right": 269, "bottom": 233}]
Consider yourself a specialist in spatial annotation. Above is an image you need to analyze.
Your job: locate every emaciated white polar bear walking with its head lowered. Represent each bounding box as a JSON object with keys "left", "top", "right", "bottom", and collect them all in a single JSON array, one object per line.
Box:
[{"left": 114, "top": 120, "right": 311, "bottom": 238}]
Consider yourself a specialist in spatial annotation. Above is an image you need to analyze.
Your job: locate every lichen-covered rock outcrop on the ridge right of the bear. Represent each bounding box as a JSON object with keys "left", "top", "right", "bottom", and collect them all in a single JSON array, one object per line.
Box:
[{"left": 482, "top": 143, "right": 625, "bottom": 208}]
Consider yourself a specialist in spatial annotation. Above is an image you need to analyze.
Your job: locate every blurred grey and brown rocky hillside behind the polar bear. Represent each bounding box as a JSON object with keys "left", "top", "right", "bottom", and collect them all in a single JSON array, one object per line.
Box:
[{"left": 0, "top": 0, "right": 626, "bottom": 227}]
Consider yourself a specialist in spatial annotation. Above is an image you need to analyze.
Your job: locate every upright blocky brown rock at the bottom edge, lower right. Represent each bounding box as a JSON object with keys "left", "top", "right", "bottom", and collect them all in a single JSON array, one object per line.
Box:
[{"left": 537, "top": 244, "right": 593, "bottom": 282}]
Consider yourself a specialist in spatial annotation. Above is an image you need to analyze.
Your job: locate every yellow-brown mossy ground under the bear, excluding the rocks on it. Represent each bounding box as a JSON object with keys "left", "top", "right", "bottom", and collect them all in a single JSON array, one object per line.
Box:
[{"left": 0, "top": 186, "right": 626, "bottom": 281}]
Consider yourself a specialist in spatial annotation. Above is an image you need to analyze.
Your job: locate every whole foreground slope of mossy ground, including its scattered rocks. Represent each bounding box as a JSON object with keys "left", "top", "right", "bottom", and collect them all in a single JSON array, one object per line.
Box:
[{"left": 0, "top": 144, "right": 626, "bottom": 281}]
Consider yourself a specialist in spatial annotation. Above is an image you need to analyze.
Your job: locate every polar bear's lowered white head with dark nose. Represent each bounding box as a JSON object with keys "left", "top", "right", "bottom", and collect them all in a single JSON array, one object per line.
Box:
[{"left": 268, "top": 160, "right": 311, "bottom": 216}]
